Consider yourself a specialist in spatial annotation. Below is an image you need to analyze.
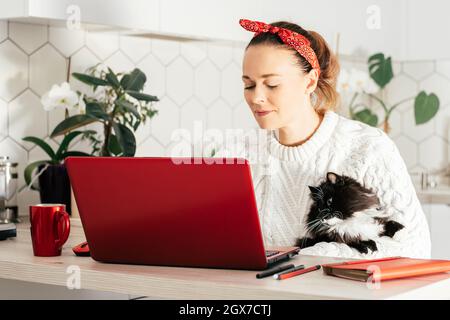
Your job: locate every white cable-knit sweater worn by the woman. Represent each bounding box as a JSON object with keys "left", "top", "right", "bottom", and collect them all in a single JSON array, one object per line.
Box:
[{"left": 227, "top": 111, "right": 431, "bottom": 258}]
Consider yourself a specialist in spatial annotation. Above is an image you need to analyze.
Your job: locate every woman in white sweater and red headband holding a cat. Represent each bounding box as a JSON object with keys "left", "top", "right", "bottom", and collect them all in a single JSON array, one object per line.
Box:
[{"left": 240, "top": 19, "right": 431, "bottom": 258}]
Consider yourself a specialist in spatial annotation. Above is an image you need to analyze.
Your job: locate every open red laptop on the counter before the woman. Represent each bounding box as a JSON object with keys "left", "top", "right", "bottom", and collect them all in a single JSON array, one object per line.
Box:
[{"left": 66, "top": 157, "right": 300, "bottom": 270}]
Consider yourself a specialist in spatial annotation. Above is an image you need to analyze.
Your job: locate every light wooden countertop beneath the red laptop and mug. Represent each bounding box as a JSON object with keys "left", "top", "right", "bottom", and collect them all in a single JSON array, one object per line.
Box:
[{"left": 0, "top": 219, "right": 450, "bottom": 299}]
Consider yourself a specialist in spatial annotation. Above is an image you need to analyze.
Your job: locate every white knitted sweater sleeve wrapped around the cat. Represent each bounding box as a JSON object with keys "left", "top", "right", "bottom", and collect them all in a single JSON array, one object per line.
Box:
[{"left": 300, "top": 128, "right": 431, "bottom": 259}]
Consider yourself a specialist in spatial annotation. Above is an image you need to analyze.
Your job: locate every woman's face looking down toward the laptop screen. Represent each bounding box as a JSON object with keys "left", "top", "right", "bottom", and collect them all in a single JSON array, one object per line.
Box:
[{"left": 242, "top": 45, "right": 317, "bottom": 130}]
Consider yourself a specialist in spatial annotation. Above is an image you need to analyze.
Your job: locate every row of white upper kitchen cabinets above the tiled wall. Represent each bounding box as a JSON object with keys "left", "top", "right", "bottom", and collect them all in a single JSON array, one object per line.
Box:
[{"left": 0, "top": 0, "right": 444, "bottom": 61}]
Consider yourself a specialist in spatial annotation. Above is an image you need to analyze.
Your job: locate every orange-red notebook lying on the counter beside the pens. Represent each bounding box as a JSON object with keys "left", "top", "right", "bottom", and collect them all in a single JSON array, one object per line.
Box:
[{"left": 322, "top": 257, "right": 450, "bottom": 282}]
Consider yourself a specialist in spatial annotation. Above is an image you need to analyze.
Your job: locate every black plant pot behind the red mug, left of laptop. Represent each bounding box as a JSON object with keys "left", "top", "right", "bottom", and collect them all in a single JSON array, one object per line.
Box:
[{"left": 38, "top": 164, "right": 72, "bottom": 214}]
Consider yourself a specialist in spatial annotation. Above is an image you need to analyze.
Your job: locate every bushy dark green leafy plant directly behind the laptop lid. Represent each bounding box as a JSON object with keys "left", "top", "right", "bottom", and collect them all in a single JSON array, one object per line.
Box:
[{"left": 51, "top": 65, "right": 159, "bottom": 156}]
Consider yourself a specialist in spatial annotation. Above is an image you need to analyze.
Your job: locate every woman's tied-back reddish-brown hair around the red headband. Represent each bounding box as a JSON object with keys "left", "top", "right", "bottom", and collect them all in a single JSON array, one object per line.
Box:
[{"left": 246, "top": 21, "right": 339, "bottom": 114}]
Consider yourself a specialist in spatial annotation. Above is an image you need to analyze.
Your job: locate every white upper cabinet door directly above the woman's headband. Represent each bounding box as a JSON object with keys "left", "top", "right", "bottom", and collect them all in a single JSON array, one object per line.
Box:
[{"left": 160, "top": 0, "right": 346, "bottom": 45}]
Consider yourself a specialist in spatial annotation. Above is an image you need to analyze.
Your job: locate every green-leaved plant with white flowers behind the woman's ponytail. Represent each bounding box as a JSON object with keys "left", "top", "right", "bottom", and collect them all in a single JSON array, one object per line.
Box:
[{"left": 338, "top": 53, "right": 439, "bottom": 133}]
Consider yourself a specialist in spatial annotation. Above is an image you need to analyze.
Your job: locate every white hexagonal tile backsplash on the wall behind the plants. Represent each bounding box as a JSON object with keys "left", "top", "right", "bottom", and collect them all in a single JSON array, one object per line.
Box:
[{"left": 0, "top": 21, "right": 450, "bottom": 211}]
